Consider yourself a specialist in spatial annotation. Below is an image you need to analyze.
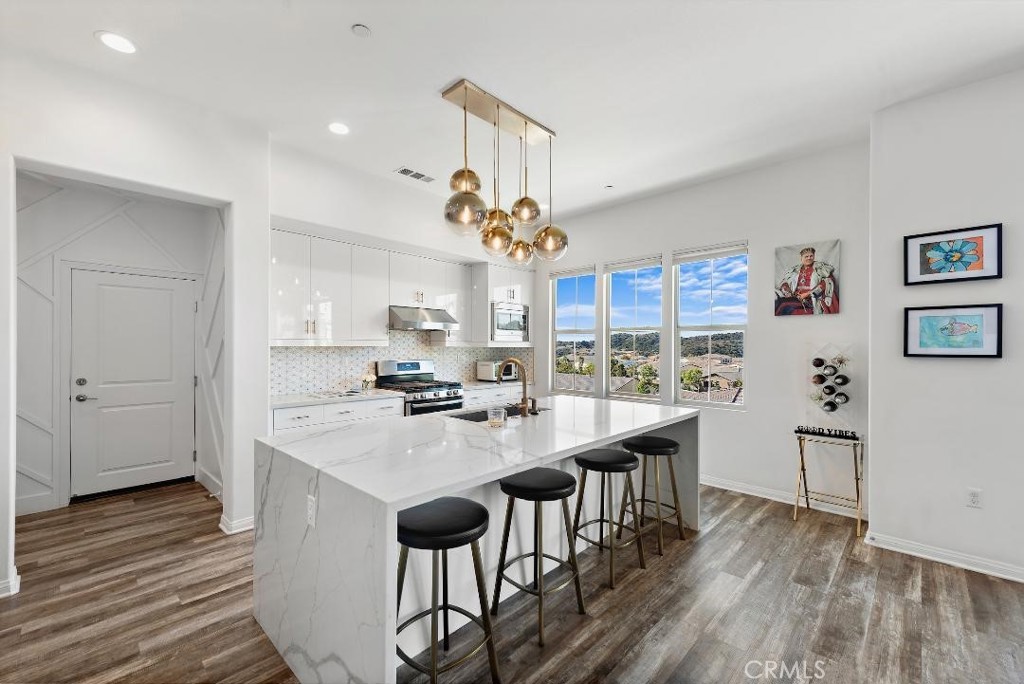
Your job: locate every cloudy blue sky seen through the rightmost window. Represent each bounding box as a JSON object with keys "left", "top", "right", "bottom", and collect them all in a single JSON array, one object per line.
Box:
[{"left": 679, "top": 254, "right": 746, "bottom": 326}]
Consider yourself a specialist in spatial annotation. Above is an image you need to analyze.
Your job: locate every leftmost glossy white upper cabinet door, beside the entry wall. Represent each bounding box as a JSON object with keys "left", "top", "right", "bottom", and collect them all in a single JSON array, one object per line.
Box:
[{"left": 270, "top": 230, "right": 311, "bottom": 341}]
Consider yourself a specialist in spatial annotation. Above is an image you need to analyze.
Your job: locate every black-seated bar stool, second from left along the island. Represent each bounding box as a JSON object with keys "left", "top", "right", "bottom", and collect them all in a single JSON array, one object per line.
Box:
[{"left": 490, "top": 468, "right": 587, "bottom": 646}]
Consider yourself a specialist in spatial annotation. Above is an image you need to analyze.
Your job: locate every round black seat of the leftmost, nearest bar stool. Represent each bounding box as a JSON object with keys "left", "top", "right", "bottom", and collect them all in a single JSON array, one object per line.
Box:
[{"left": 398, "top": 497, "right": 488, "bottom": 551}]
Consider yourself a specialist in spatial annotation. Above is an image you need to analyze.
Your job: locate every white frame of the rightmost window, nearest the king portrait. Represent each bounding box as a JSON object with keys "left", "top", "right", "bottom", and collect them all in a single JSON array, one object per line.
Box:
[{"left": 675, "top": 241, "right": 751, "bottom": 411}]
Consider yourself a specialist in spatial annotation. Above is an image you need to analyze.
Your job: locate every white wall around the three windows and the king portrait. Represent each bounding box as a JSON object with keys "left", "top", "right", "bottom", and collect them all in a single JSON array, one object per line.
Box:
[{"left": 537, "top": 144, "right": 867, "bottom": 516}]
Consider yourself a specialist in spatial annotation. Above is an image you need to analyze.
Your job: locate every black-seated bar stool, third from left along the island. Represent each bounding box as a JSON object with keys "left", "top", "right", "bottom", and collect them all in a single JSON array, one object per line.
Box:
[{"left": 572, "top": 448, "right": 647, "bottom": 589}]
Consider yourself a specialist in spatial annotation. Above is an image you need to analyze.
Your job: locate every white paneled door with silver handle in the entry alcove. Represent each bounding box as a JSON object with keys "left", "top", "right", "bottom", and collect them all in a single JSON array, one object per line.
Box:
[{"left": 70, "top": 269, "right": 196, "bottom": 497}]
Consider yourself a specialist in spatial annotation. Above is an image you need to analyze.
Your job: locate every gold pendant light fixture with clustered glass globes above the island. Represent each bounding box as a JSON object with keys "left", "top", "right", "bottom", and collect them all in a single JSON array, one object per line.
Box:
[{"left": 441, "top": 79, "right": 568, "bottom": 266}]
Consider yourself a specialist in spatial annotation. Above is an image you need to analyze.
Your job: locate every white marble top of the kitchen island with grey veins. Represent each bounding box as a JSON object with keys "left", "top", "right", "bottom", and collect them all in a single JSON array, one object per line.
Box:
[{"left": 257, "top": 395, "right": 699, "bottom": 510}]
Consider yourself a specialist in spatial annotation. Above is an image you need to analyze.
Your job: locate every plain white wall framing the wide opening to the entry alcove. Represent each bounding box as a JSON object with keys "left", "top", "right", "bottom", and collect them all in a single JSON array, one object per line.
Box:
[{"left": 0, "top": 57, "right": 269, "bottom": 593}]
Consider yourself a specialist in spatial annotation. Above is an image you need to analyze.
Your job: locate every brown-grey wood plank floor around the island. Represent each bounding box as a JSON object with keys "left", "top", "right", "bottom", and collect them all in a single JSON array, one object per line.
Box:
[{"left": 0, "top": 483, "right": 1024, "bottom": 684}]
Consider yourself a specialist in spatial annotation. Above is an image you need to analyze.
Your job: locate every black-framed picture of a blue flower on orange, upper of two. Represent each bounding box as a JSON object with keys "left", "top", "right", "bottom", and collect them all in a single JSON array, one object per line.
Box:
[{"left": 903, "top": 223, "right": 1002, "bottom": 285}]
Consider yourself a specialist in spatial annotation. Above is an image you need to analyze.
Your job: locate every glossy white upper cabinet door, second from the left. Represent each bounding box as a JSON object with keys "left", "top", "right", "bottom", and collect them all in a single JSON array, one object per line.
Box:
[{"left": 309, "top": 238, "right": 352, "bottom": 342}]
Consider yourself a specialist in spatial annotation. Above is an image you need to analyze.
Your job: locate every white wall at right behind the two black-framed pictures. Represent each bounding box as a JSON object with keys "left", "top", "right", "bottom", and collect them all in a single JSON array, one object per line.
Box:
[{"left": 869, "top": 66, "right": 1024, "bottom": 581}]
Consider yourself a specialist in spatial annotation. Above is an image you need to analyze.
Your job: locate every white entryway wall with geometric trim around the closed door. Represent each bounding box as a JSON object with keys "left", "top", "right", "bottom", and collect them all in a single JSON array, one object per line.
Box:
[{"left": 15, "top": 172, "right": 223, "bottom": 515}]
